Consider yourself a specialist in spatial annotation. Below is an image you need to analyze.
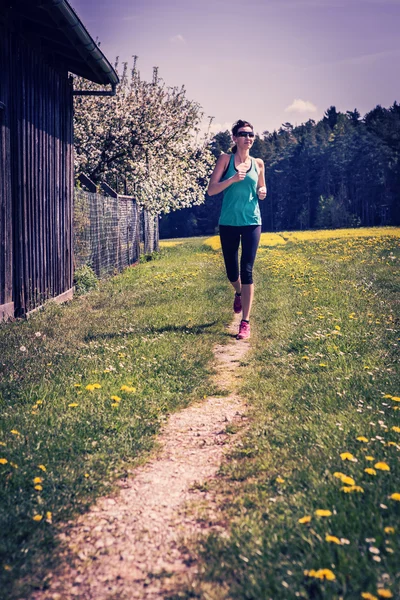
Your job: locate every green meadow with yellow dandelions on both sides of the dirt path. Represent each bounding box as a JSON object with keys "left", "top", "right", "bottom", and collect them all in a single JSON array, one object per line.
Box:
[{"left": 0, "top": 228, "right": 400, "bottom": 600}]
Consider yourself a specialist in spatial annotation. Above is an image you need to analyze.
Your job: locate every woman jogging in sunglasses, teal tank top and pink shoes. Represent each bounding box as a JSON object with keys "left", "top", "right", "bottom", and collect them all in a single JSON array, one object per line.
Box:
[{"left": 208, "top": 120, "right": 267, "bottom": 340}]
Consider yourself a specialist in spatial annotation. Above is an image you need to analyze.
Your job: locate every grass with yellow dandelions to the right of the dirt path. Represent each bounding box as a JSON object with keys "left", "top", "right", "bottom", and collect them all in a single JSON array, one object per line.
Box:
[{"left": 188, "top": 230, "right": 400, "bottom": 600}]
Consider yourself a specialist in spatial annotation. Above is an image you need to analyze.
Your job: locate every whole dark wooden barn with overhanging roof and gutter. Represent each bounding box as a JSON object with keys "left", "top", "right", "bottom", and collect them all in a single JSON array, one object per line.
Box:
[{"left": 0, "top": 0, "right": 118, "bottom": 320}]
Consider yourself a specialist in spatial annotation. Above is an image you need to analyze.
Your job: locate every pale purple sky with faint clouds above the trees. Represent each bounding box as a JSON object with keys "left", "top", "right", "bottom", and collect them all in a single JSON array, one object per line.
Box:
[{"left": 68, "top": 0, "right": 400, "bottom": 134}]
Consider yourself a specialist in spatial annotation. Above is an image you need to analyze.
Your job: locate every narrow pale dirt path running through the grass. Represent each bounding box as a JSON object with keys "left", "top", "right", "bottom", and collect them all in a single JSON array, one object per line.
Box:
[{"left": 32, "top": 318, "right": 249, "bottom": 600}]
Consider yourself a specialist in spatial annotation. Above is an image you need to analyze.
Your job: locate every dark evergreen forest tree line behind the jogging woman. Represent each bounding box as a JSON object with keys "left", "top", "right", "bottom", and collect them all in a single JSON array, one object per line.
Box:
[{"left": 160, "top": 102, "right": 400, "bottom": 238}]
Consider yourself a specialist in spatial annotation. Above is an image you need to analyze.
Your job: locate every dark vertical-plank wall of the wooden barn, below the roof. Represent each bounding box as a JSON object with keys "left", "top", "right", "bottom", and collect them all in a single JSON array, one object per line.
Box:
[{"left": 0, "top": 23, "right": 73, "bottom": 318}]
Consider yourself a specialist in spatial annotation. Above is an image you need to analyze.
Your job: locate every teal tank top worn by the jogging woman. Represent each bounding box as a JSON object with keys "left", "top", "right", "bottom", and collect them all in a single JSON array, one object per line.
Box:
[{"left": 218, "top": 154, "right": 261, "bottom": 227}]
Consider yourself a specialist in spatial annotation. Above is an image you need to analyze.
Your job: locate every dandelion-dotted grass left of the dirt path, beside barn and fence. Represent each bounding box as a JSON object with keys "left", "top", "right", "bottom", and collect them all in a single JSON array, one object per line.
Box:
[{"left": 0, "top": 240, "right": 231, "bottom": 598}]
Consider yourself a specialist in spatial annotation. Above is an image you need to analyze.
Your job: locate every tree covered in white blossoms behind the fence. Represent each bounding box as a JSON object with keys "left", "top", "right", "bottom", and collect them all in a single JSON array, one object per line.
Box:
[{"left": 74, "top": 58, "right": 214, "bottom": 213}]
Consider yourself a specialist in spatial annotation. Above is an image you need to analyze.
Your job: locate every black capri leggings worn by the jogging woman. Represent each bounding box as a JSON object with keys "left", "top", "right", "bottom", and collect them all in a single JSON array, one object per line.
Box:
[{"left": 219, "top": 225, "right": 261, "bottom": 284}]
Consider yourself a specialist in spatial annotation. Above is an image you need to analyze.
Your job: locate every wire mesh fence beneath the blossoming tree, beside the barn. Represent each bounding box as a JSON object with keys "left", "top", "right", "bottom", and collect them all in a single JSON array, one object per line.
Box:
[{"left": 74, "top": 188, "right": 159, "bottom": 278}]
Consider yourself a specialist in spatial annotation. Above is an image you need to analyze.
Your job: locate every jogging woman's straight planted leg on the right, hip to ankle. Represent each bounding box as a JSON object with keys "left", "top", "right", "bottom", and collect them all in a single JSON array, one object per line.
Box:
[{"left": 240, "top": 225, "right": 261, "bottom": 321}]
